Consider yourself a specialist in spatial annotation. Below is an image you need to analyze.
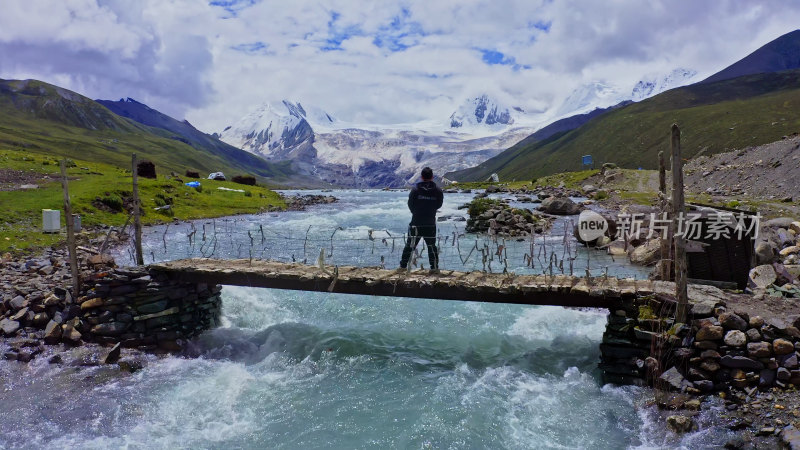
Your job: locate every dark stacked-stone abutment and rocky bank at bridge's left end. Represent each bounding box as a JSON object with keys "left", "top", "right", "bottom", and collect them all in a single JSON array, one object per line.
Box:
[{"left": 0, "top": 247, "right": 220, "bottom": 362}]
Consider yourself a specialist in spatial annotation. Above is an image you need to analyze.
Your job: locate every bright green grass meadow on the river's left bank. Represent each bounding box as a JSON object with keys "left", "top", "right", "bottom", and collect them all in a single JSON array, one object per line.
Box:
[{"left": 0, "top": 148, "right": 285, "bottom": 252}]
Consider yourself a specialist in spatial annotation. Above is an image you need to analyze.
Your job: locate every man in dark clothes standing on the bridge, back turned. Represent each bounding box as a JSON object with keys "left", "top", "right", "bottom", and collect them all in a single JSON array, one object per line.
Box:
[{"left": 398, "top": 167, "right": 444, "bottom": 273}]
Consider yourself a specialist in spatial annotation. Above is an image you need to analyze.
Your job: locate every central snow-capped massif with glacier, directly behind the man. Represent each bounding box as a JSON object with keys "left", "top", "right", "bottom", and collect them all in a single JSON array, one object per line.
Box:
[{"left": 220, "top": 95, "right": 534, "bottom": 187}]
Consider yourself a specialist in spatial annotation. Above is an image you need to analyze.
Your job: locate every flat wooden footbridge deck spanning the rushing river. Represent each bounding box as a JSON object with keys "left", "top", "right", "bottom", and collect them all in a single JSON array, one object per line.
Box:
[{"left": 150, "top": 258, "right": 725, "bottom": 310}]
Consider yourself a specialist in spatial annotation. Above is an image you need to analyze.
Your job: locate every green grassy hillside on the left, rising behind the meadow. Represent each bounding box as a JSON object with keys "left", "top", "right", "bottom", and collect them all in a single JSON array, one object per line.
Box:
[{"left": 0, "top": 80, "right": 290, "bottom": 184}]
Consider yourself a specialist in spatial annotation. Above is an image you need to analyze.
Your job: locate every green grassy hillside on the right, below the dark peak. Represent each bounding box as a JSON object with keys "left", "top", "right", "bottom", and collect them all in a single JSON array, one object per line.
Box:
[{"left": 446, "top": 70, "right": 800, "bottom": 181}]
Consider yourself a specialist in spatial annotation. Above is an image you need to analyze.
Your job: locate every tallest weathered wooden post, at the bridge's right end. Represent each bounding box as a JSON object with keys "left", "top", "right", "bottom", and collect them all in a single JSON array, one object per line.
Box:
[{"left": 672, "top": 124, "right": 689, "bottom": 323}]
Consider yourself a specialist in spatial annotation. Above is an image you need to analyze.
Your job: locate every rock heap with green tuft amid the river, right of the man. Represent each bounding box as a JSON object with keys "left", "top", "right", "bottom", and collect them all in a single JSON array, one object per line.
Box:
[{"left": 466, "top": 198, "right": 550, "bottom": 237}]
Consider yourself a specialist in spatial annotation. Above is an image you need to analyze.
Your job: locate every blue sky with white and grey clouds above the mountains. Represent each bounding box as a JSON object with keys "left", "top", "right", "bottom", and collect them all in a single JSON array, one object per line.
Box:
[{"left": 0, "top": 0, "right": 800, "bottom": 132}]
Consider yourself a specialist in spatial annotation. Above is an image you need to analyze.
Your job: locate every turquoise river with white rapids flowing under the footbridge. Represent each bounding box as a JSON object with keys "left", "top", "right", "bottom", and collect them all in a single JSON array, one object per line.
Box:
[{"left": 0, "top": 191, "right": 736, "bottom": 449}]
